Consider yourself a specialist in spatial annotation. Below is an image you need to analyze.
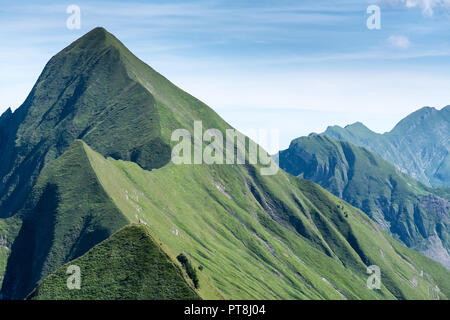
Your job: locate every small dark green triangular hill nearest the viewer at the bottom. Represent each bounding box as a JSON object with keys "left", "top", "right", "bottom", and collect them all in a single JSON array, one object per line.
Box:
[{"left": 29, "top": 224, "right": 199, "bottom": 300}]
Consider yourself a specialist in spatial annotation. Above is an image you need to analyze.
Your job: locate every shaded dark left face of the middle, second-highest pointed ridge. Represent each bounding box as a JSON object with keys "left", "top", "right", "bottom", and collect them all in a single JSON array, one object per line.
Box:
[{"left": 2, "top": 141, "right": 129, "bottom": 298}]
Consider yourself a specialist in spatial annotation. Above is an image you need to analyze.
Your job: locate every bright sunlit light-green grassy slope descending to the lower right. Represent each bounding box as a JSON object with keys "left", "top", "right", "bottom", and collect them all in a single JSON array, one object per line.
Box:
[{"left": 75, "top": 141, "right": 450, "bottom": 299}]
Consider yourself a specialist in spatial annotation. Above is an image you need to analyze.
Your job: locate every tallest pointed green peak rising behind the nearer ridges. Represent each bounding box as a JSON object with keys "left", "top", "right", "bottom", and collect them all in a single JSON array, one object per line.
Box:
[{"left": 0, "top": 28, "right": 236, "bottom": 296}]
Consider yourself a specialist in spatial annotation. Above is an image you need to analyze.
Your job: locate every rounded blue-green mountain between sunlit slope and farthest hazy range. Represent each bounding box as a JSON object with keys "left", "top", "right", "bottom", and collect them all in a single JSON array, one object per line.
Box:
[{"left": 279, "top": 135, "right": 450, "bottom": 268}]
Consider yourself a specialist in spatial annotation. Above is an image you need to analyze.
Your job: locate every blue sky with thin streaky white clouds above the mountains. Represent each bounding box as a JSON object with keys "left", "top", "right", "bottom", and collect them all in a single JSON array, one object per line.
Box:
[{"left": 0, "top": 0, "right": 450, "bottom": 148}]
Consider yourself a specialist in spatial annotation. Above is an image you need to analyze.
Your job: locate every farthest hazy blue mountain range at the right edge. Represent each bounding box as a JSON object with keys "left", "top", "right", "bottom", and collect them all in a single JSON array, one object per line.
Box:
[{"left": 324, "top": 106, "right": 450, "bottom": 187}]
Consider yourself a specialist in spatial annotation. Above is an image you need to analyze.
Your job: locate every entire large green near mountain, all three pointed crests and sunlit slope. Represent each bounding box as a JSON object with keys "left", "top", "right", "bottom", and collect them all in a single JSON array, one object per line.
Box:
[{"left": 0, "top": 28, "right": 450, "bottom": 299}]
